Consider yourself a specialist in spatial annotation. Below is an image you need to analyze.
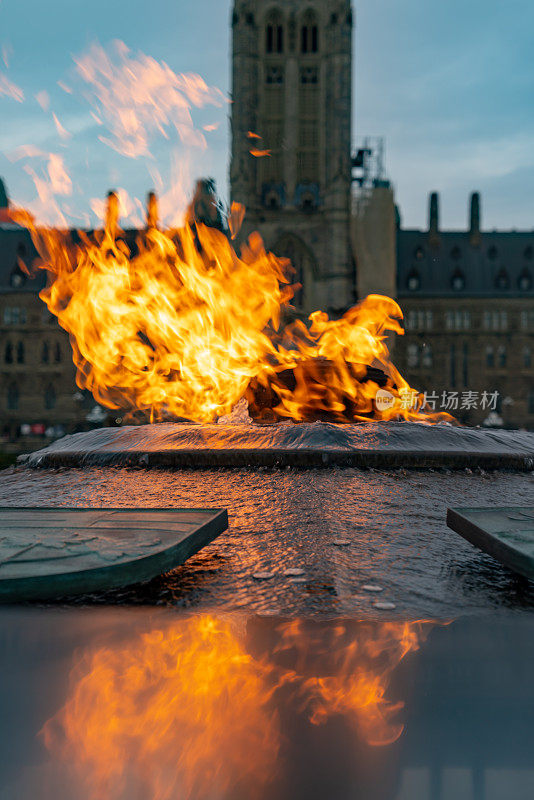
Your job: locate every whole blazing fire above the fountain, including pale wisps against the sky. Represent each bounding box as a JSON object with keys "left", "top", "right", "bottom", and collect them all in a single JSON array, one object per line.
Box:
[{"left": 5, "top": 42, "right": 449, "bottom": 422}]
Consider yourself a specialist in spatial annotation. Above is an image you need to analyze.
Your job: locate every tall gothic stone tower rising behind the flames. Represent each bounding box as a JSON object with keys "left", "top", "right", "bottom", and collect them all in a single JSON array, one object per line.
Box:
[{"left": 230, "top": 0, "right": 355, "bottom": 314}]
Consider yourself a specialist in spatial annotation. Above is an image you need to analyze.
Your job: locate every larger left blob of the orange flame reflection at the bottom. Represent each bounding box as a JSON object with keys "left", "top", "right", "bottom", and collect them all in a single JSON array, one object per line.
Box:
[{"left": 44, "top": 616, "right": 280, "bottom": 800}]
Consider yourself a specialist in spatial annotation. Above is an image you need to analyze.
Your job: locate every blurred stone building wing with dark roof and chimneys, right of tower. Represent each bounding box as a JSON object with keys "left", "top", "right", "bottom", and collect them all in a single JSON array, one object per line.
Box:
[{"left": 395, "top": 193, "right": 534, "bottom": 428}]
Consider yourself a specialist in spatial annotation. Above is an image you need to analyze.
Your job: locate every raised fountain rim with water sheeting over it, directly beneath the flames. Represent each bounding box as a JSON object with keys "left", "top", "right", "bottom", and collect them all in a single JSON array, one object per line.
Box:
[{"left": 19, "top": 422, "right": 534, "bottom": 471}]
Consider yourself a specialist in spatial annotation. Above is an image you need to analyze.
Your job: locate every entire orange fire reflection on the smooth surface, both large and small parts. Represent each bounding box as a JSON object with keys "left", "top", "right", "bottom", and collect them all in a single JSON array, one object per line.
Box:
[{"left": 43, "top": 615, "right": 431, "bottom": 800}]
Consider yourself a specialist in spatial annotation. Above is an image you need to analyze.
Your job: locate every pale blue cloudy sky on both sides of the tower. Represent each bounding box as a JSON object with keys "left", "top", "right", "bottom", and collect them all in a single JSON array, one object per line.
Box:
[{"left": 0, "top": 0, "right": 534, "bottom": 230}]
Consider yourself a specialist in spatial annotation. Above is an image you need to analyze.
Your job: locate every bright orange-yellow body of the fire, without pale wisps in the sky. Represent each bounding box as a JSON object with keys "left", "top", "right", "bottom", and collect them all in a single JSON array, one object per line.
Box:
[{"left": 15, "top": 193, "right": 448, "bottom": 421}]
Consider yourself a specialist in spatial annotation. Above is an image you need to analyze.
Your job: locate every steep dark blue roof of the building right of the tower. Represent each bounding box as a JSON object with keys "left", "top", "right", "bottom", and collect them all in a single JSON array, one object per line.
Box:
[{"left": 397, "top": 230, "right": 534, "bottom": 298}]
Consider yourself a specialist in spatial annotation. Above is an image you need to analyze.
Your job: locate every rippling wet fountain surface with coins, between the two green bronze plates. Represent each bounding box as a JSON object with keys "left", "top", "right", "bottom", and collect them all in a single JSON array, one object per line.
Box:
[{"left": 0, "top": 468, "right": 534, "bottom": 619}]
